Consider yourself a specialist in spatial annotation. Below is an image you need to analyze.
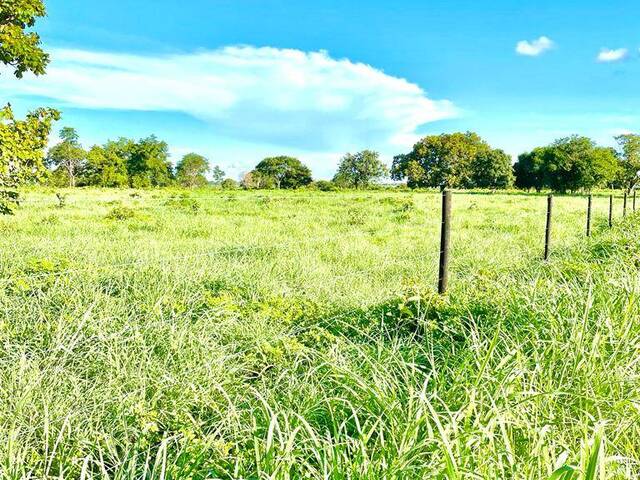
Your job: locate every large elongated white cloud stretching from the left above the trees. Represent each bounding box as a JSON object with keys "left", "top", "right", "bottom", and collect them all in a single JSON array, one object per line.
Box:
[{"left": 0, "top": 46, "right": 456, "bottom": 151}]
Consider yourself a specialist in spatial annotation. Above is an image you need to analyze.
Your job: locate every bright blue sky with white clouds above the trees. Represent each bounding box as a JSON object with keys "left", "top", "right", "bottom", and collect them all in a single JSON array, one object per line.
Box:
[{"left": 0, "top": 0, "right": 640, "bottom": 178}]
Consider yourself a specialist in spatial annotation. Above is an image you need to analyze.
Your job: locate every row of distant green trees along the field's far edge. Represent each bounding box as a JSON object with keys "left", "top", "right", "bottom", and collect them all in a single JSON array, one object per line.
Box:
[{"left": 42, "top": 128, "right": 640, "bottom": 192}]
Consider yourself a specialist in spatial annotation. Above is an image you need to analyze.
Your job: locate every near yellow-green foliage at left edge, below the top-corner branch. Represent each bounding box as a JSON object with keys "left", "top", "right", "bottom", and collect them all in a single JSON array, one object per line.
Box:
[{"left": 0, "top": 107, "right": 60, "bottom": 214}]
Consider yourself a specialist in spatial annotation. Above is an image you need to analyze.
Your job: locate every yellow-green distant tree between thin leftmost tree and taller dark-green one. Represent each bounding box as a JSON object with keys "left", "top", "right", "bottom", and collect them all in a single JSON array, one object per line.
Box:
[{"left": 84, "top": 142, "right": 129, "bottom": 188}]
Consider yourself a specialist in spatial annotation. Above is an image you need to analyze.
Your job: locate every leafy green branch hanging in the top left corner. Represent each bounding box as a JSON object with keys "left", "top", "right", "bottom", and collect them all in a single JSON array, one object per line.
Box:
[{"left": 0, "top": 0, "right": 49, "bottom": 78}]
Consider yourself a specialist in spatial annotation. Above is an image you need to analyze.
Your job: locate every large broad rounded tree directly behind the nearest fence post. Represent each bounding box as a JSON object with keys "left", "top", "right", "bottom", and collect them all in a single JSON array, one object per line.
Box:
[{"left": 391, "top": 132, "right": 492, "bottom": 188}]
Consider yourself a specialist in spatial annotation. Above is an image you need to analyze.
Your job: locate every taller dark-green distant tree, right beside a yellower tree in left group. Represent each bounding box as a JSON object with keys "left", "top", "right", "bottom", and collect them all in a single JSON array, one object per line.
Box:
[{"left": 127, "top": 135, "right": 173, "bottom": 188}]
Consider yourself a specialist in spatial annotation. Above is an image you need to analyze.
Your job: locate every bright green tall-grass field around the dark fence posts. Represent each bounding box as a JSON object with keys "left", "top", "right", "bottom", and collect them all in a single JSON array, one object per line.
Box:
[{"left": 0, "top": 190, "right": 640, "bottom": 480}]
